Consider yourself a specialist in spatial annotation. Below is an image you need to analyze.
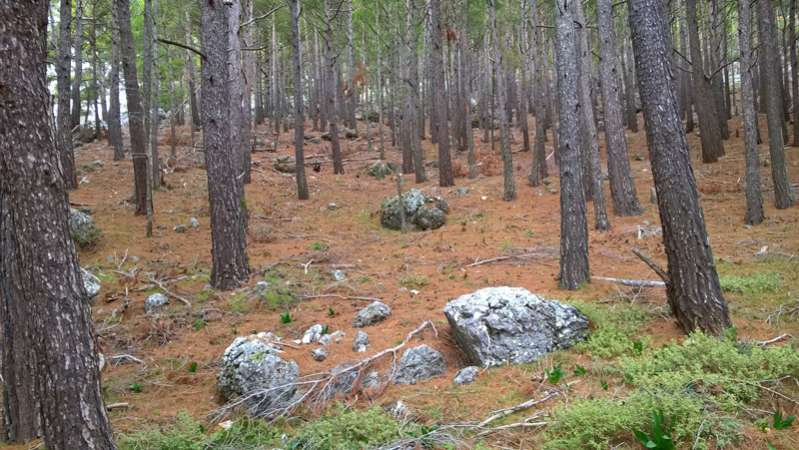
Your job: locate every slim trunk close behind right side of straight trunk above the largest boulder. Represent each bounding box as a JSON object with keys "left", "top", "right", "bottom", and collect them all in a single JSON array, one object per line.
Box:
[{"left": 572, "top": 1, "right": 610, "bottom": 231}]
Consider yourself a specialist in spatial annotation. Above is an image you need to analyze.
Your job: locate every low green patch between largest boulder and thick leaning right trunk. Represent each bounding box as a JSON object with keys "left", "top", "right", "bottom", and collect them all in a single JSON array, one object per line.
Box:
[{"left": 571, "top": 302, "right": 650, "bottom": 359}]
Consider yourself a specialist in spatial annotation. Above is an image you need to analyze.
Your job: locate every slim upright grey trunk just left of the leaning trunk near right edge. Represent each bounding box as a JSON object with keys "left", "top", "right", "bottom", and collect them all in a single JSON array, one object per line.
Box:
[{"left": 738, "top": 0, "right": 764, "bottom": 225}]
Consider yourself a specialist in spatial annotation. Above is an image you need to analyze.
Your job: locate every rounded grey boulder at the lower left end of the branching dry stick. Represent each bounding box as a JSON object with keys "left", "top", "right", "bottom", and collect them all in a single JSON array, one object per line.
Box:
[{"left": 217, "top": 333, "right": 300, "bottom": 418}]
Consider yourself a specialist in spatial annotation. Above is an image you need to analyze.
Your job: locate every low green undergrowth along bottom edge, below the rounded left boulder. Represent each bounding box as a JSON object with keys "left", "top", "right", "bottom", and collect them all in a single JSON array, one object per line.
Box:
[{"left": 118, "top": 406, "right": 430, "bottom": 450}]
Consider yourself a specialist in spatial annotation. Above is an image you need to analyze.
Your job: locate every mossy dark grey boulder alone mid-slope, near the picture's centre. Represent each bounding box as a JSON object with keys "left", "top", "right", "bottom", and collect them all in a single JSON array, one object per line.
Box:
[{"left": 380, "top": 189, "right": 449, "bottom": 230}]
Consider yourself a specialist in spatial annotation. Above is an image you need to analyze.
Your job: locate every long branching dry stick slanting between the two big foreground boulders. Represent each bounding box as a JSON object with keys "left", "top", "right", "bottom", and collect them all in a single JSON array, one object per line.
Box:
[{"left": 211, "top": 320, "right": 438, "bottom": 422}]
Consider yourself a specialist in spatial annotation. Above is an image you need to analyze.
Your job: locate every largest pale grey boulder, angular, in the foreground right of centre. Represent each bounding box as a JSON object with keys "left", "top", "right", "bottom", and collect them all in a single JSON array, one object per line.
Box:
[{"left": 444, "top": 287, "right": 588, "bottom": 367}]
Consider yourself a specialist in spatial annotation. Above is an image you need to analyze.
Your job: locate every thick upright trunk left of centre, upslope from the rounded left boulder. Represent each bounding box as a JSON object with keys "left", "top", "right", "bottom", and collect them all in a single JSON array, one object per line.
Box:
[{"left": 201, "top": 0, "right": 249, "bottom": 290}]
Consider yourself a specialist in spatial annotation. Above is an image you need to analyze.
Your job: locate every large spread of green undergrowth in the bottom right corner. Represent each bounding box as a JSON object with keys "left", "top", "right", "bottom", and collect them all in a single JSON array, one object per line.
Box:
[{"left": 544, "top": 333, "right": 799, "bottom": 449}]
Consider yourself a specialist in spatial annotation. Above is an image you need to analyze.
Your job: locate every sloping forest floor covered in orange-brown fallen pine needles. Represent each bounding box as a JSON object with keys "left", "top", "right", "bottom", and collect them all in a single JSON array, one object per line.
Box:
[{"left": 32, "top": 120, "right": 799, "bottom": 449}]
